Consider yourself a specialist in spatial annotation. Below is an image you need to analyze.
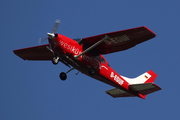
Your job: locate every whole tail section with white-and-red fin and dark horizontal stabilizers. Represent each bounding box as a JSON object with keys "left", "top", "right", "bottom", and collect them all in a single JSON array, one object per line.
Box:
[{"left": 106, "top": 70, "right": 161, "bottom": 99}]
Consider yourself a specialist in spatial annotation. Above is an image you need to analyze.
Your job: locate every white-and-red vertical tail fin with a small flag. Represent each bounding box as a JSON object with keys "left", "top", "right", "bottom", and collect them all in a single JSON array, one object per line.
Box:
[{"left": 121, "top": 70, "right": 157, "bottom": 85}]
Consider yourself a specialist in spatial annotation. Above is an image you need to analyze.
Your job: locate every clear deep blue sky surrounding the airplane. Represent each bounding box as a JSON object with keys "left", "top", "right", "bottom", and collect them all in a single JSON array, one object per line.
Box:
[{"left": 0, "top": 0, "right": 180, "bottom": 120}]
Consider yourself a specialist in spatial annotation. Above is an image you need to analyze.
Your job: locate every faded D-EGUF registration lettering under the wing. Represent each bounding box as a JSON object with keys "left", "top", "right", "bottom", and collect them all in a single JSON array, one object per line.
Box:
[{"left": 104, "top": 35, "right": 130, "bottom": 45}]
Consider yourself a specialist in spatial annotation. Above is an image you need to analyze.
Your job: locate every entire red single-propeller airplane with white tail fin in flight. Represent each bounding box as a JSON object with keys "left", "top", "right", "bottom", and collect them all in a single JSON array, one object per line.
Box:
[{"left": 13, "top": 20, "right": 161, "bottom": 99}]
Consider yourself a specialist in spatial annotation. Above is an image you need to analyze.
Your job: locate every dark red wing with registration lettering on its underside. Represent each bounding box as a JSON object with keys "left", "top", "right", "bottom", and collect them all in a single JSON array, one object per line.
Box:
[{"left": 82, "top": 26, "right": 156, "bottom": 54}]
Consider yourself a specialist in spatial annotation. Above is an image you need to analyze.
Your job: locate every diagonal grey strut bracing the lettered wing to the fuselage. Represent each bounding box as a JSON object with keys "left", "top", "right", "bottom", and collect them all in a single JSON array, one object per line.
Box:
[{"left": 74, "top": 35, "right": 109, "bottom": 60}]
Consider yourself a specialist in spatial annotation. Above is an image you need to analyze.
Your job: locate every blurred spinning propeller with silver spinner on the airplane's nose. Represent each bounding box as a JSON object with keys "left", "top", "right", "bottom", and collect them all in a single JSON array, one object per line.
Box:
[{"left": 39, "top": 20, "right": 60, "bottom": 44}]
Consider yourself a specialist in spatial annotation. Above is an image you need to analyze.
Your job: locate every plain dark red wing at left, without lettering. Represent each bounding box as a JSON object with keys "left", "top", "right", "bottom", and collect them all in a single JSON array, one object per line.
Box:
[{"left": 13, "top": 44, "right": 53, "bottom": 60}]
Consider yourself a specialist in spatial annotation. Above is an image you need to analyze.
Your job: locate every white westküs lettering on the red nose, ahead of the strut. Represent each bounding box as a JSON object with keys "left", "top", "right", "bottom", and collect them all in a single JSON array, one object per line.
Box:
[{"left": 59, "top": 40, "right": 81, "bottom": 55}]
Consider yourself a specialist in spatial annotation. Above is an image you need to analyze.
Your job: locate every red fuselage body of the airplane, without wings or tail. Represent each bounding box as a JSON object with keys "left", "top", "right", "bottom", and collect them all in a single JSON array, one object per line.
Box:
[{"left": 49, "top": 34, "right": 134, "bottom": 92}]
